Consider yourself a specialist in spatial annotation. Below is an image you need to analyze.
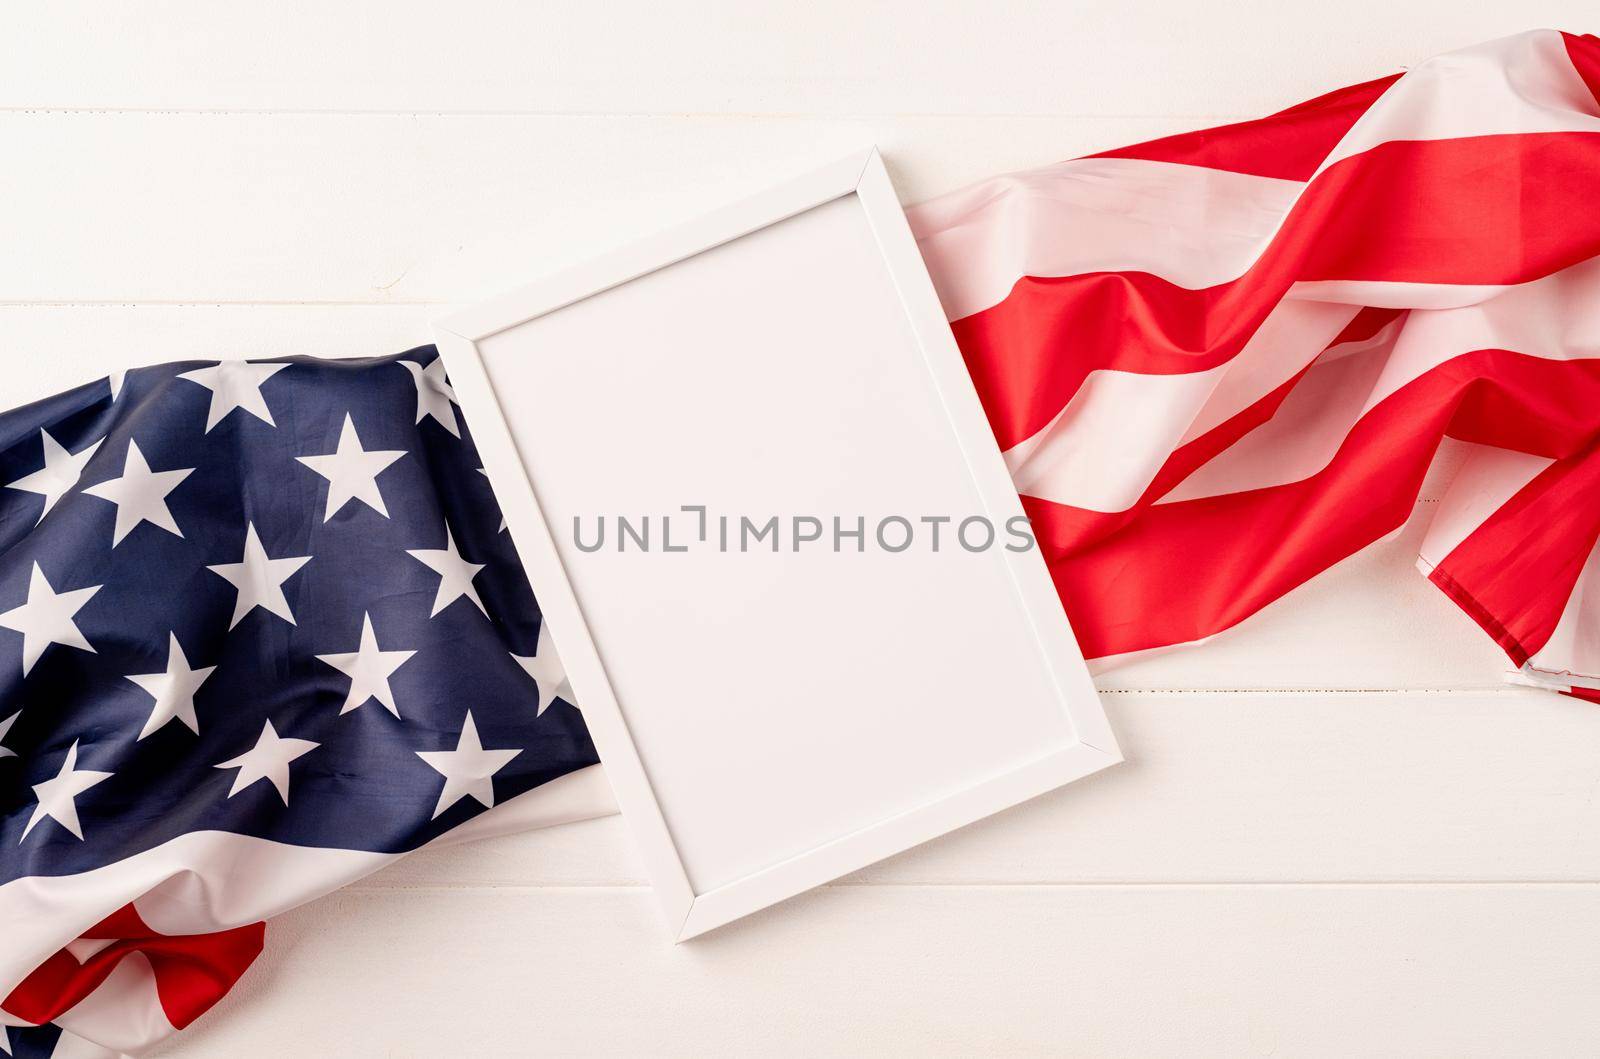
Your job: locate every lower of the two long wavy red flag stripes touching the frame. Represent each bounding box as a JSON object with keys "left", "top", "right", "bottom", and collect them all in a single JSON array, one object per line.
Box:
[{"left": 1024, "top": 350, "right": 1600, "bottom": 657}]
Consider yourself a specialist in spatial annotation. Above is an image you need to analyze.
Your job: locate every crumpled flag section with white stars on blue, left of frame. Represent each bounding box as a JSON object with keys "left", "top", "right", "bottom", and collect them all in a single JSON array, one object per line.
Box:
[{"left": 0, "top": 347, "right": 603, "bottom": 1056}]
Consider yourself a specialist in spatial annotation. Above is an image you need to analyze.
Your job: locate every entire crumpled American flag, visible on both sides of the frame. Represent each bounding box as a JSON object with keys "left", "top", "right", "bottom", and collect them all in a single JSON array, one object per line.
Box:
[{"left": 0, "top": 32, "right": 1600, "bottom": 1054}]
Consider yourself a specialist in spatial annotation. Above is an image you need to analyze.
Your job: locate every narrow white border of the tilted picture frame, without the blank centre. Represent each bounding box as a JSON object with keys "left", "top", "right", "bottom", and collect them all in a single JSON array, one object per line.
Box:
[{"left": 434, "top": 147, "right": 1122, "bottom": 941}]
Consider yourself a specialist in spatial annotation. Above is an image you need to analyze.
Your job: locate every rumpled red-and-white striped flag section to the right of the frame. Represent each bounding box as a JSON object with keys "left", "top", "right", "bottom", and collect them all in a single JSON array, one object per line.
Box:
[{"left": 910, "top": 30, "right": 1600, "bottom": 697}]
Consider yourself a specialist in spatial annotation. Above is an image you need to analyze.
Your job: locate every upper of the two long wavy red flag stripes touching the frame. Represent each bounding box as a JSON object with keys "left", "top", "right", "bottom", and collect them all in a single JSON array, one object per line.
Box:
[{"left": 952, "top": 133, "right": 1600, "bottom": 448}]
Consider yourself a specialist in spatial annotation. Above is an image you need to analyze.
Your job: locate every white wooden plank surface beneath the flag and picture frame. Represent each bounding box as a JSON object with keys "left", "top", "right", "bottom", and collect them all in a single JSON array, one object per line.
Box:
[{"left": 0, "top": 0, "right": 1600, "bottom": 1057}]
